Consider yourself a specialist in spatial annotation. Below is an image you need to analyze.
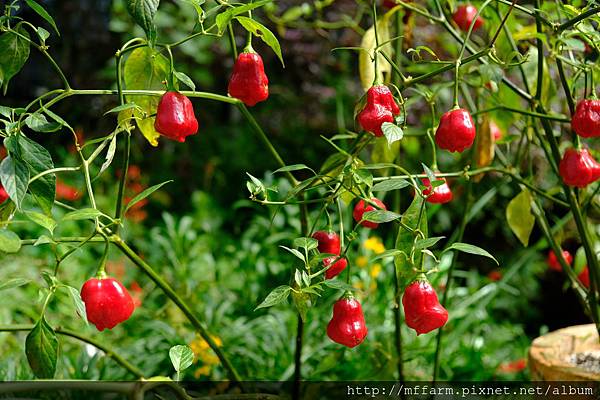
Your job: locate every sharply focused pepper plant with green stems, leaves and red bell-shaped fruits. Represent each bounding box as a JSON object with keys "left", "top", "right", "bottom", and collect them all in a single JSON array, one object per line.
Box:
[{"left": 0, "top": 0, "right": 600, "bottom": 397}]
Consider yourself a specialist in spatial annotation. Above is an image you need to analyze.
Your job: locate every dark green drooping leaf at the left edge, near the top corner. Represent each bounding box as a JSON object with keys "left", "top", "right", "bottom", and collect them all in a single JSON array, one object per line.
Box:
[{"left": 0, "top": 25, "right": 29, "bottom": 95}]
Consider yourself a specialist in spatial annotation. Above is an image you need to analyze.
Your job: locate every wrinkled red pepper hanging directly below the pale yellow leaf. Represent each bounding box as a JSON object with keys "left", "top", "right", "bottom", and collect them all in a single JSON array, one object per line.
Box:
[{"left": 357, "top": 85, "right": 400, "bottom": 136}]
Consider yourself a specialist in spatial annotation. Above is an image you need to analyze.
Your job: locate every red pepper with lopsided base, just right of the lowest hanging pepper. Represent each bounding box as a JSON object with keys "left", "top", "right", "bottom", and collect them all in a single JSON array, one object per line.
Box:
[{"left": 402, "top": 279, "right": 448, "bottom": 335}]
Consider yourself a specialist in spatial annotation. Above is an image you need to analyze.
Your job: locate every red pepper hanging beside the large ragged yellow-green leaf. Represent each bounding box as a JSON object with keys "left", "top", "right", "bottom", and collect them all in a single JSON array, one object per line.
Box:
[{"left": 154, "top": 92, "right": 198, "bottom": 143}]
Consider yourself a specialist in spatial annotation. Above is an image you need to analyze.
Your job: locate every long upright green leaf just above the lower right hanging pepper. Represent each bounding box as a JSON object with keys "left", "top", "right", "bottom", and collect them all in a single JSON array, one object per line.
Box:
[{"left": 394, "top": 196, "right": 427, "bottom": 289}]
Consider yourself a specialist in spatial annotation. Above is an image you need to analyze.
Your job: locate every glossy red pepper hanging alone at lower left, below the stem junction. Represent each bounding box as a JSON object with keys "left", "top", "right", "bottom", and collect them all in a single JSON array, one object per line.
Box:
[{"left": 81, "top": 278, "right": 135, "bottom": 331}]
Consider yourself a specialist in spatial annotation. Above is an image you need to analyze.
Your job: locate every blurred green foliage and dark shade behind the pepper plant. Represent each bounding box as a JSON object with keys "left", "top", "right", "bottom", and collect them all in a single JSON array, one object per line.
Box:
[{"left": 0, "top": 0, "right": 587, "bottom": 380}]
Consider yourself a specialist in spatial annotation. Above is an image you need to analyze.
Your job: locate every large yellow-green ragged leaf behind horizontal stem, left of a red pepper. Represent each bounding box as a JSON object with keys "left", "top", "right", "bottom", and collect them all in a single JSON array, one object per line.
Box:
[{"left": 123, "top": 47, "right": 169, "bottom": 146}]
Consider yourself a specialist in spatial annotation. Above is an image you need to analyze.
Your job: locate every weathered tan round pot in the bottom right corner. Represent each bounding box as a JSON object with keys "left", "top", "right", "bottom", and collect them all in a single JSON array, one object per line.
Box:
[{"left": 529, "top": 324, "right": 600, "bottom": 381}]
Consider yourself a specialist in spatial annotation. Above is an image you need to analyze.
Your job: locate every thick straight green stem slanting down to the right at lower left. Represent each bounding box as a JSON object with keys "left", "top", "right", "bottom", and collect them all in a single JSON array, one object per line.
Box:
[{"left": 112, "top": 236, "right": 242, "bottom": 386}]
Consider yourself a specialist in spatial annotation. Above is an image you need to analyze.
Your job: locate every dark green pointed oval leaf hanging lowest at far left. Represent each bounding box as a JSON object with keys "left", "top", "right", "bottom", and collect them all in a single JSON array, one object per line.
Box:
[{"left": 25, "top": 317, "right": 58, "bottom": 379}]
